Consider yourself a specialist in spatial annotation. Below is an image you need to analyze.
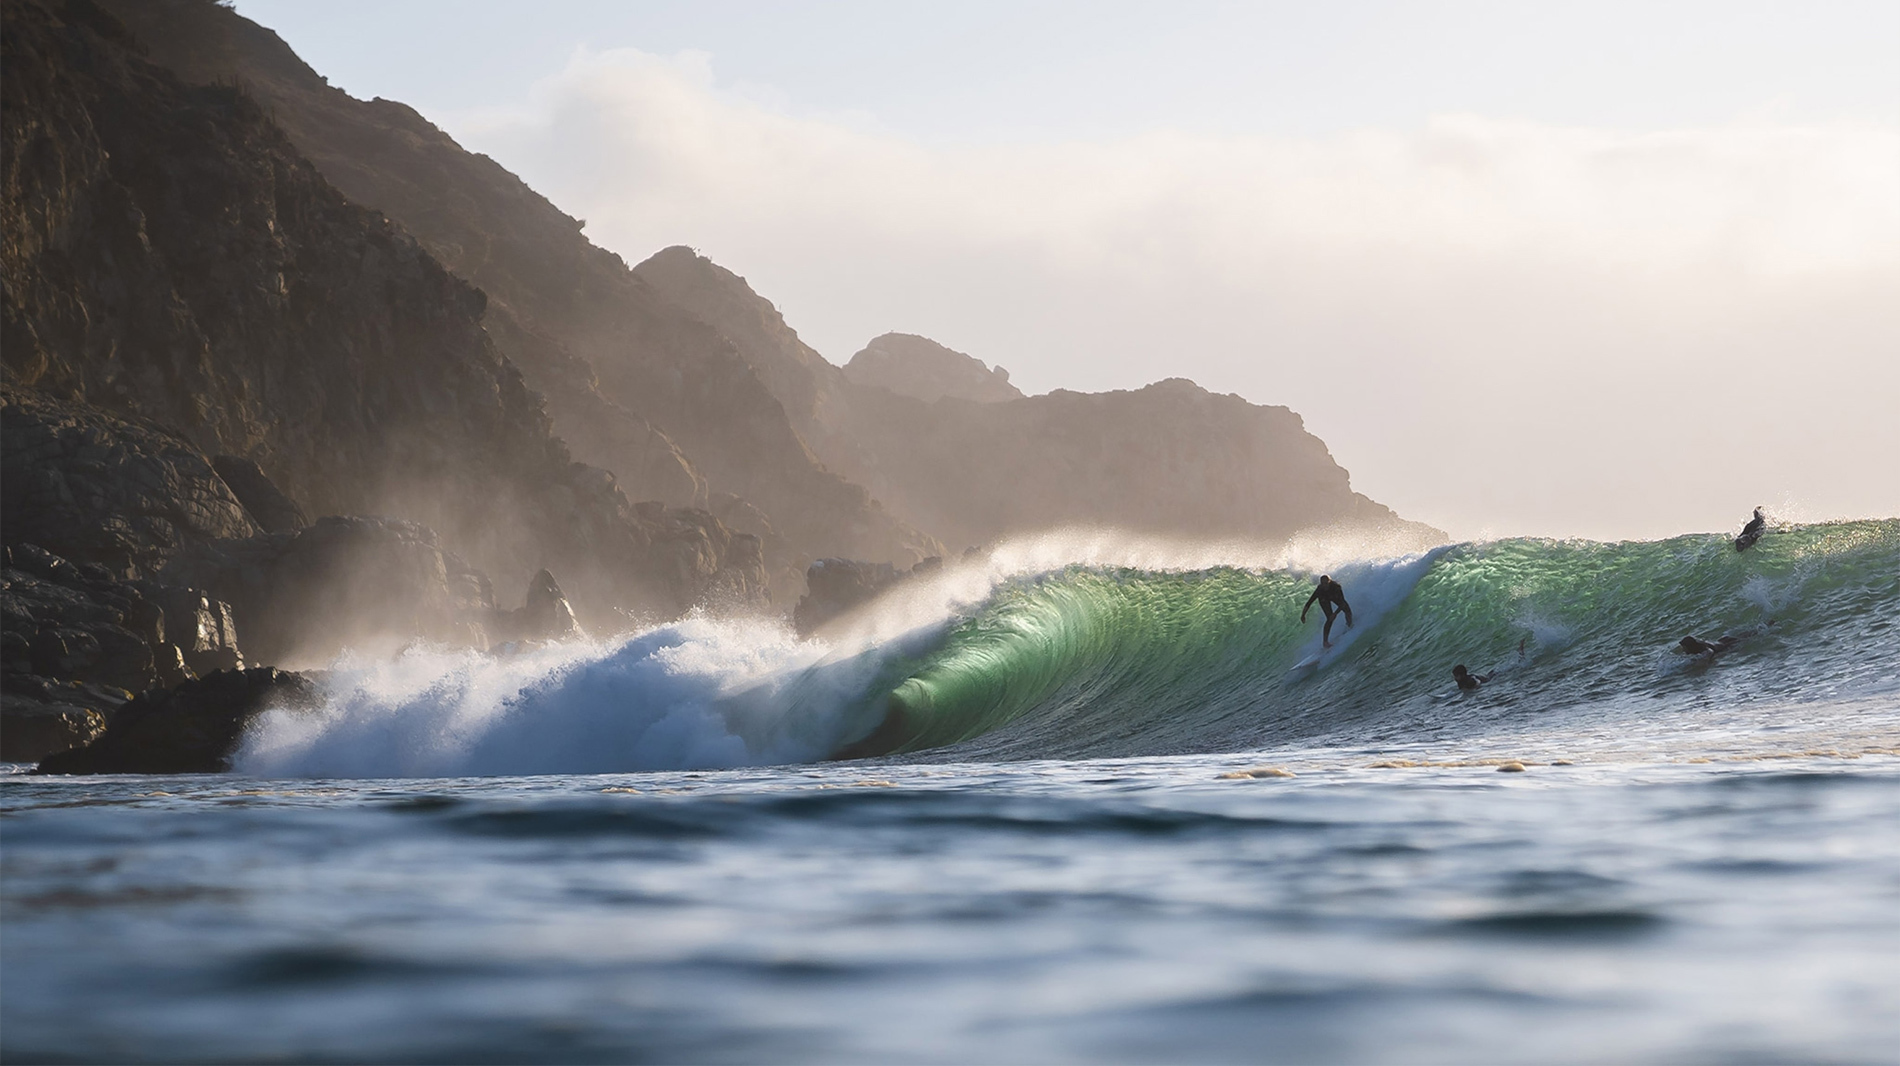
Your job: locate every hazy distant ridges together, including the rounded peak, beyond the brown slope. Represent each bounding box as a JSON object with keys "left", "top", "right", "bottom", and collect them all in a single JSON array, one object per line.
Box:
[{"left": 604, "top": 247, "right": 1442, "bottom": 551}]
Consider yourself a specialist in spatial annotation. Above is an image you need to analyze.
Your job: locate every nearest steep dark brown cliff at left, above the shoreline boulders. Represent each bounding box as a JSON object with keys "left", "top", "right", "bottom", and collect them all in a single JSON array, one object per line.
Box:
[{"left": 0, "top": 0, "right": 764, "bottom": 619}]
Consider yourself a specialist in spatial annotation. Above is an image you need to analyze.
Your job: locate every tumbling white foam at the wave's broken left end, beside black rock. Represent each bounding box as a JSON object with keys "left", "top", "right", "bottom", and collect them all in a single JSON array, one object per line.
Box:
[{"left": 234, "top": 618, "right": 876, "bottom": 777}]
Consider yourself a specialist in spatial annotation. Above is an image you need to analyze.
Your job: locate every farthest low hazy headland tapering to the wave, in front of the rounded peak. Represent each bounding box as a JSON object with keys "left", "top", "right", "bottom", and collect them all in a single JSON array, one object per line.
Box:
[{"left": 851, "top": 378, "right": 1442, "bottom": 547}]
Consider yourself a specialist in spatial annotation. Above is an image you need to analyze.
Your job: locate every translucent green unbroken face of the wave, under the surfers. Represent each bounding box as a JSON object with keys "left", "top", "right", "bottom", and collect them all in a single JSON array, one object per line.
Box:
[{"left": 851, "top": 519, "right": 1900, "bottom": 758}]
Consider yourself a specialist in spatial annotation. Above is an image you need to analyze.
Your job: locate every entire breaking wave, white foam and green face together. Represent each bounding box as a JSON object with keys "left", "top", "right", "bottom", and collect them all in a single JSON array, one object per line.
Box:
[{"left": 238, "top": 519, "right": 1900, "bottom": 777}]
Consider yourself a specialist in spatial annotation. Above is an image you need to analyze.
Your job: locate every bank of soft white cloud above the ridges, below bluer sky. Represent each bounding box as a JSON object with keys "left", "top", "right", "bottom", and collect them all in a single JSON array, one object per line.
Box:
[{"left": 450, "top": 51, "right": 1900, "bottom": 536}]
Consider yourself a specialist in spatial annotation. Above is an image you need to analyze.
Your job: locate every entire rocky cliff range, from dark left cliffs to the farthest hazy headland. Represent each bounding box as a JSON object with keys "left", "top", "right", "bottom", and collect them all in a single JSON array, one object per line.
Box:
[{"left": 0, "top": 0, "right": 1435, "bottom": 766}]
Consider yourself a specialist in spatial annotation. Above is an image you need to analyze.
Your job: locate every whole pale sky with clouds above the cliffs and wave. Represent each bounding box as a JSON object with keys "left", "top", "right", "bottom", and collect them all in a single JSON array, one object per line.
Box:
[{"left": 238, "top": 0, "right": 1900, "bottom": 538}]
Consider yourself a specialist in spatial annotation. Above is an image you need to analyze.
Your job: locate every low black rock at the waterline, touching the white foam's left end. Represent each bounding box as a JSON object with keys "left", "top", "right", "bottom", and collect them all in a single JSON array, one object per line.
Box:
[{"left": 34, "top": 667, "right": 323, "bottom": 773}]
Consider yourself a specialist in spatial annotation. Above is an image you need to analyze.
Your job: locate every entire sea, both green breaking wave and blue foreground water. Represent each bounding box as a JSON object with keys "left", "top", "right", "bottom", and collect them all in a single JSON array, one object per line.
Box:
[{"left": 0, "top": 521, "right": 1900, "bottom": 1062}]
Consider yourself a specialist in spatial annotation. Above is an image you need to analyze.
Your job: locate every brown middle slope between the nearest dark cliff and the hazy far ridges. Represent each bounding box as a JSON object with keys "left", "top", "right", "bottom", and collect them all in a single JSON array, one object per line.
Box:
[{"left": 94, "top": 0, "right": 939, "bottom": 589}]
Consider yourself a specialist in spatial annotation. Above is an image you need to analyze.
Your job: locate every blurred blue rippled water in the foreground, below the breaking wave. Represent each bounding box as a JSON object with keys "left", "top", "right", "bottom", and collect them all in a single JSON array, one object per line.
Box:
[{"left": 0, "top": 741, "right": 1900, "bottom": 1062}]
